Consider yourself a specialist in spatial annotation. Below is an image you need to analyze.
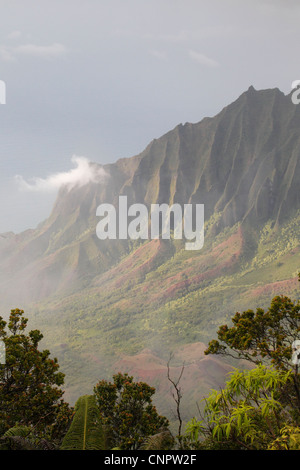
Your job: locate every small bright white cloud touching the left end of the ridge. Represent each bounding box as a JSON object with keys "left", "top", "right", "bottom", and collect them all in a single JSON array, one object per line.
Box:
[{"left": 15, "top": 155, "right": 108, "bottom": 192}]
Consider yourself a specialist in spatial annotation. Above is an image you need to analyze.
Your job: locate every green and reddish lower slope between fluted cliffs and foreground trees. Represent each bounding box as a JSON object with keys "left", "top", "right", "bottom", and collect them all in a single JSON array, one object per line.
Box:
[{"left": 26, "top": 207, "right": 300, "bottom": 424}]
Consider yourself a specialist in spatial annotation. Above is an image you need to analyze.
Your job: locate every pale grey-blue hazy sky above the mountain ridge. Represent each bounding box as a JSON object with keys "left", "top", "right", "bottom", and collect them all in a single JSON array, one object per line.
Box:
[{"left": 0, "top": 0, "right": 300, "bottom": 232}]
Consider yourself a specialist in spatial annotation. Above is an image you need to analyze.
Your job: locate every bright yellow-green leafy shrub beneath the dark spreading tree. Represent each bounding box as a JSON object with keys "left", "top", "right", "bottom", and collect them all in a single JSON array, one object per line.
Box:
[{"left": 184, "top": 365, "right": 300, "bottom": 450}]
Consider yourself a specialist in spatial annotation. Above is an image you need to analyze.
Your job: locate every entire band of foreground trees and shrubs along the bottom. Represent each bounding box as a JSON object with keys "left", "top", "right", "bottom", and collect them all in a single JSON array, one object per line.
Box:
[{"left": 0, "top": 273, "right": 300, "bottom": 450}]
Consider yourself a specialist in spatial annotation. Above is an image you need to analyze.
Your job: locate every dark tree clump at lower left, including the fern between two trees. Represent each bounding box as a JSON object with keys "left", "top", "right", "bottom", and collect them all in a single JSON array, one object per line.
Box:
[{"left": 0, "top": 309, "right": 169, "bottom": 450}]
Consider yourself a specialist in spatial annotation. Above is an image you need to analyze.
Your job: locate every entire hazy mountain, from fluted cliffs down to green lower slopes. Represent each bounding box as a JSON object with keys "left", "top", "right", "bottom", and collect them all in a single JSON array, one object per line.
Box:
[{"left": 0, "top": 87, "right": 300, "bottom": 422}]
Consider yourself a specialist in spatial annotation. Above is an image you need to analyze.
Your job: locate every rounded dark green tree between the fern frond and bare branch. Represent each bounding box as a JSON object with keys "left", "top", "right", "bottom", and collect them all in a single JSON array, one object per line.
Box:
[{"left": 94, "top": 373, "right": 169, "bottom": 449}]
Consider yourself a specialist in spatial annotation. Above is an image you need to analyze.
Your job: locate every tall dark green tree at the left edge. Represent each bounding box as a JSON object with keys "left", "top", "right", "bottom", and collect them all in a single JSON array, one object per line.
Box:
[{"left": 0, "top": 309, "right": 72, "bottom": 443}]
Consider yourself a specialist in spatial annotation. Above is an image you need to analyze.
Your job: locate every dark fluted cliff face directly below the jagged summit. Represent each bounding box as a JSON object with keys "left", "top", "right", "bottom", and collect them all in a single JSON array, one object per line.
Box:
[{"left": 125, "top": 88, "right": 300, "bottom": 229}]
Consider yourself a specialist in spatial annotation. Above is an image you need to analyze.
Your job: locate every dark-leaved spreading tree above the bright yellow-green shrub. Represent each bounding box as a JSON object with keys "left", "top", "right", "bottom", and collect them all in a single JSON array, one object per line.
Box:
[{"left": 205, "top": 296, "right": 300, "bottom": 413}]
